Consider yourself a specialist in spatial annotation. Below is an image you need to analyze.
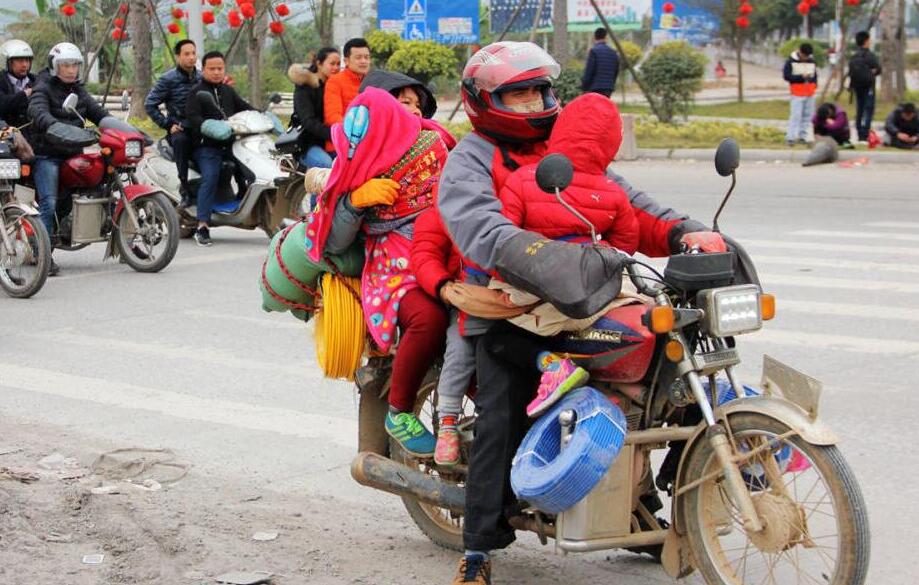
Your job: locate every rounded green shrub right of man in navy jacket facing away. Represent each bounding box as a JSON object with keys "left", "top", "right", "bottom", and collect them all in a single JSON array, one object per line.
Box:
[{"left": 641, "top": 41, "right": 708, "bottom": 122}]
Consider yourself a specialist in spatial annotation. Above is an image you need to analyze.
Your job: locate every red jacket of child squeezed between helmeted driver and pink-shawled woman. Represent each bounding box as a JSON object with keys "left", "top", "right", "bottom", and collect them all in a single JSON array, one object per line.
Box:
[{"left": 411, "top": 206, "right": 461, "bottom": 299}]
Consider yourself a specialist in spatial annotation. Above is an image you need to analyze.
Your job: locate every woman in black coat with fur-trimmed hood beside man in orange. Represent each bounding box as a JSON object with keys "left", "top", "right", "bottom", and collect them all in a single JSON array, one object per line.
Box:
[{"left": 287, "top": 47, "right": 341, "bottom": 168}]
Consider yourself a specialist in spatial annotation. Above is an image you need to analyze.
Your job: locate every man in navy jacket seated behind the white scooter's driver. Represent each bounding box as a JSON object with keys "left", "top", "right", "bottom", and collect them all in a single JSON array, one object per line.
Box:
[{"left": 144, "top": 39, "right": 201, "bottom": 204}]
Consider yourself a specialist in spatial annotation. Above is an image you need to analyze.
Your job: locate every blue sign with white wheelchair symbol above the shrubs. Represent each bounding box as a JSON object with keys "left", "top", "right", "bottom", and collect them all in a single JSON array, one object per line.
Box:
[{"left": 377, "top": 0, "right": 479, "bottom": 45}]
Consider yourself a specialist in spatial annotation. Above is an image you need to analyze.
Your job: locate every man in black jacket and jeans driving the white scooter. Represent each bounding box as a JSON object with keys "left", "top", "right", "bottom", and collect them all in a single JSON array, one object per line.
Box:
[{"left": 185, "top": 51, "right": 255, "bottom": 246}]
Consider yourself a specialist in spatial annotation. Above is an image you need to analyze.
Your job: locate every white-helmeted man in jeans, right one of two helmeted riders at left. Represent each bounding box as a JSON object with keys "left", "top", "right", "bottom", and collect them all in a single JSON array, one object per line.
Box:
[{"left": 26, "top": 43, "right": 111, "bottom": 274}]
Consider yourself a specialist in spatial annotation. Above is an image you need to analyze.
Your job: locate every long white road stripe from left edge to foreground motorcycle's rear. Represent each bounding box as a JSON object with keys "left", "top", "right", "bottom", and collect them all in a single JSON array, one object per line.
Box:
[{"left": 0, "top": 363, "right": 357, "bottom": 448}]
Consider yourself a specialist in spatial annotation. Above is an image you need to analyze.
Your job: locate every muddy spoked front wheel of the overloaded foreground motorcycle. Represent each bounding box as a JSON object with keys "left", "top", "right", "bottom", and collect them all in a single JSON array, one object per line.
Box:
[{"left": 682, "top": 413, "right": 870, "bottom": 585}]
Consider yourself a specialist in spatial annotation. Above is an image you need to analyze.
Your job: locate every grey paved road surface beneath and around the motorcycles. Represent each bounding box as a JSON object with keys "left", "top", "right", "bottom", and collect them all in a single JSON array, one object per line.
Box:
[{"left": 0, "top": 162, "right": 919, "bottom": 585}]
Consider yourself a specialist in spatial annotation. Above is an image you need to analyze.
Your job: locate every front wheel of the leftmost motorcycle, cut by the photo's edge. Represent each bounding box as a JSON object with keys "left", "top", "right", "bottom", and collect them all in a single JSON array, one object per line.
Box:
[{"left": 0, "top": 209, "right": 51, "bottom": 299}]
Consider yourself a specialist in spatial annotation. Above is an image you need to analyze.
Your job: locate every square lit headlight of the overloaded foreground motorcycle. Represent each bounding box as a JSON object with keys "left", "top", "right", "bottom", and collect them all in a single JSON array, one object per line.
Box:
[{"left": 698, "top": 284, "right": 763, "bottom": 337}]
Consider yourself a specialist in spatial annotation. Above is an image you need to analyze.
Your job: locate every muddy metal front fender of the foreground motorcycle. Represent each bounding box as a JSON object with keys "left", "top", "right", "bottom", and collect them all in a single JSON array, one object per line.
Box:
[{"left": 672, "top": 396, "right": 839, "bottom": 534}]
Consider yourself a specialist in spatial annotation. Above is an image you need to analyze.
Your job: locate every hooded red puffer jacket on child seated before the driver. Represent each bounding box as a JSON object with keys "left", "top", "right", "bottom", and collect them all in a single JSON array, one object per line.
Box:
[{"left": 499, "top": 93, "right": 640, "bottom": 254}]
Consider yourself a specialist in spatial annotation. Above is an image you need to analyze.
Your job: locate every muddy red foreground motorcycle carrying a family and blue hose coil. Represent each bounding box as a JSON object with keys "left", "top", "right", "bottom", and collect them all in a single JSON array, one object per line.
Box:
[{"left": 351, "top": 139, "right": 870, "bottom": 585}]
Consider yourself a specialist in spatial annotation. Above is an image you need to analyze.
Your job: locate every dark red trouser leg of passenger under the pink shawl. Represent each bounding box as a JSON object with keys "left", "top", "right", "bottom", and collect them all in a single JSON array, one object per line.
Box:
[{"left": 389, "top": 288, "right": 447, "bottom": 412}]
